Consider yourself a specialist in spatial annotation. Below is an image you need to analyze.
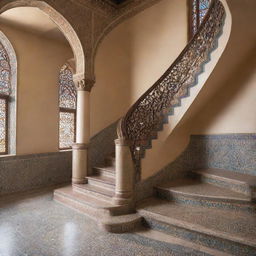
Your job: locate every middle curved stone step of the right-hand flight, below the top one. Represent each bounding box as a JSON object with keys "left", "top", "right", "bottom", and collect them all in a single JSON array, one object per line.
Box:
[{"left": 156, "top": 178, "right": 255, "bottom": 212}]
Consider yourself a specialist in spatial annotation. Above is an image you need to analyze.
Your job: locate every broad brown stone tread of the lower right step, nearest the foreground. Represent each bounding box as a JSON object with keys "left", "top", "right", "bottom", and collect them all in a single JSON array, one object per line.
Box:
[{"left": 137, "top": 198, "right": 256, "bottom": 247}]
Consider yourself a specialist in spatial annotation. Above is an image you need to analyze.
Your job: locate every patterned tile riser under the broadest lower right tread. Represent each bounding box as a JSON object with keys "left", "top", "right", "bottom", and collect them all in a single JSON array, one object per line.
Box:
[{"left": 143, "top": 216, "right": 256, "bottom": 256}]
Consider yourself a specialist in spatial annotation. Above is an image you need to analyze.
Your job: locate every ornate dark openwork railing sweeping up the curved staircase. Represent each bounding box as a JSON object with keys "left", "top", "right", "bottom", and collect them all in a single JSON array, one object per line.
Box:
[{"left": 117, "top": 0, "right": 225, "bottom": 178}]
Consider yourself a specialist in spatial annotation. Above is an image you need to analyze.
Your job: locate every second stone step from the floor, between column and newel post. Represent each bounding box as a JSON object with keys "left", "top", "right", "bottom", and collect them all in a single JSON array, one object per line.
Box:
[{"left": 73, "top": 184, "right": 115, "bottom": 202}]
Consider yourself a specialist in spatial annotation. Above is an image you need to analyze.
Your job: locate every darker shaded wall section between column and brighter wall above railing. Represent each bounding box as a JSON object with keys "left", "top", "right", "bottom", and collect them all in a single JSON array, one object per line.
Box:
[{"left": 91, "top": 24, "right": 132, "bottom": 136}]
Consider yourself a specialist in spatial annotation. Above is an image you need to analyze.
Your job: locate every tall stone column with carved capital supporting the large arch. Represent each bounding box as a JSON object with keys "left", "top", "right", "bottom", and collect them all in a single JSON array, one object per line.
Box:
[{"left": 72, "top": 75, "right": 95, "bottom": 184}]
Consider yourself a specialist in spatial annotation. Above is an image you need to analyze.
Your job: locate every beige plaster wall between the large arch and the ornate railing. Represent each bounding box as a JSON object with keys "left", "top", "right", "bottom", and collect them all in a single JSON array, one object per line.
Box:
[{"left": 91, "top": 0, "right": 187, "bottom": 135}]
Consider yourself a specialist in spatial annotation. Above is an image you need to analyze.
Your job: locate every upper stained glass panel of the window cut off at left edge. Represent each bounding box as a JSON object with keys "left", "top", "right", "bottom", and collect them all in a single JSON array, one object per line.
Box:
[{"left": 0, "top": 43, "right": 11, "bottom": 95}]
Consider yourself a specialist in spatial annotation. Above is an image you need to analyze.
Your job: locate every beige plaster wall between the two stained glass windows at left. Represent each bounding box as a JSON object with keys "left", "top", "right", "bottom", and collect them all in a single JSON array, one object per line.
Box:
[{"left": 0, "top": 24, "right": 73, "bottom": 154}]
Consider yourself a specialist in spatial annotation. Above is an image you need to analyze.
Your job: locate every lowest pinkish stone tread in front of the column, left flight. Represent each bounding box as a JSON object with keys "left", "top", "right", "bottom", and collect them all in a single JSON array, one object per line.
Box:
[{"left": 54, "top": 186, "right": 116, "bottom": 209}]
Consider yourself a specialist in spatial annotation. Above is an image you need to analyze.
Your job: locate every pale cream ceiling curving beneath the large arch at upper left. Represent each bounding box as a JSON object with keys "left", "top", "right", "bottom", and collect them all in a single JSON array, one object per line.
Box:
[{"left": 0, "top": 7, "right": 68, "bottom": 43}]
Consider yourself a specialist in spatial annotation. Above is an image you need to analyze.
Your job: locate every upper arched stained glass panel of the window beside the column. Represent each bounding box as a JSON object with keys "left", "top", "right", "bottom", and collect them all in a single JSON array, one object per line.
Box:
[{"left": 59, "top": 65, "right": 76, "bottom": 109}]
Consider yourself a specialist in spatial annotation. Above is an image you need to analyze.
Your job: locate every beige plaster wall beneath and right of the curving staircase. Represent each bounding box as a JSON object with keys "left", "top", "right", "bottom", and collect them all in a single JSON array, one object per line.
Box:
[{"left": 142, "top": 0, "right": 256, "bottom": 179}]
